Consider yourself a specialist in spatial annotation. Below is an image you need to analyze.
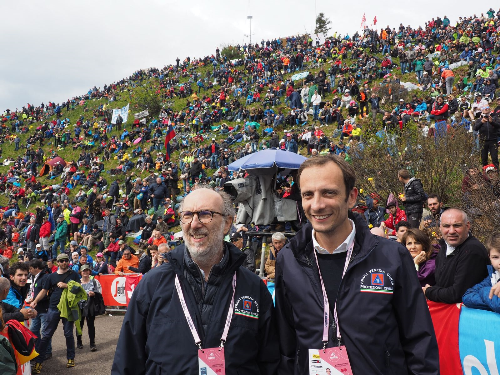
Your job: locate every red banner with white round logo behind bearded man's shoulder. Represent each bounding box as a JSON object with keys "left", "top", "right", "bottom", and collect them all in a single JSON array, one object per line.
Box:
[{"left": 96, "top": 273, "right": 142, "bottom": 306}]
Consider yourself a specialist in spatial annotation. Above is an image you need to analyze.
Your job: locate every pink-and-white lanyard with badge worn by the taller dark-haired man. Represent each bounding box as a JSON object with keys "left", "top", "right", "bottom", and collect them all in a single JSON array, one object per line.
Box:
[{"left": 309, "top": 243, "right": 354, "bottom": 375}]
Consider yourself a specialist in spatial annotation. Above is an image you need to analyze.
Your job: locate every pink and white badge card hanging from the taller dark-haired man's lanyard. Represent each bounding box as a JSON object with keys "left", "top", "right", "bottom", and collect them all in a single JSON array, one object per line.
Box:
[{"left": 309, "top": 346, "right": 352, "bottom": 375}]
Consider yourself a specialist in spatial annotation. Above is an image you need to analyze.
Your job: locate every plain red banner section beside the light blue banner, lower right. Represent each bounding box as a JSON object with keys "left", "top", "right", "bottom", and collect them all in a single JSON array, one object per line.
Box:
[{"left": 427, "top": 301, "right": 463, "bottom": 374}]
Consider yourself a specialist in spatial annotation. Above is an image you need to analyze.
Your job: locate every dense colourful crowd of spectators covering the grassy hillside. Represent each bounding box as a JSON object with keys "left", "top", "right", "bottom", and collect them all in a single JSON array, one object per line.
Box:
[{"left": 0, "top": 9, "right": 500, "bottom": 374}]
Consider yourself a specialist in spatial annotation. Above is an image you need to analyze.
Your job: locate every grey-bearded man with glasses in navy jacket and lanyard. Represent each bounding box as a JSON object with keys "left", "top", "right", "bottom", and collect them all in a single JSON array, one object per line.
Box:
[{"left": 111, "top": 188, "right": 279, "bottom": 375}]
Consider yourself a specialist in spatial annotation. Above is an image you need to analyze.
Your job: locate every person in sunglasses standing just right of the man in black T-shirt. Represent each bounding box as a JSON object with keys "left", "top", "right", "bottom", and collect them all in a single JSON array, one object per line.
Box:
[{"left": 76, "top": 264, "right": 102, "bottom": 352}]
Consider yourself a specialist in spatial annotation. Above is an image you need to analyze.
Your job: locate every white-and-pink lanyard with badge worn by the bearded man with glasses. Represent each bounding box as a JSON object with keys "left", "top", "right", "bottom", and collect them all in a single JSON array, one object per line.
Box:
[{"left": 175, "top": 272, "right": 236, "bottom": 375}]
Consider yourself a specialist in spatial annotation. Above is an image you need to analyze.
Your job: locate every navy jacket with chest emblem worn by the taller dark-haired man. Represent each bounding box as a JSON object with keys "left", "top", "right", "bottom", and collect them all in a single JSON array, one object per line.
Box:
[{"left": 276, "top": 215, "right": 439, "bottom": 375}]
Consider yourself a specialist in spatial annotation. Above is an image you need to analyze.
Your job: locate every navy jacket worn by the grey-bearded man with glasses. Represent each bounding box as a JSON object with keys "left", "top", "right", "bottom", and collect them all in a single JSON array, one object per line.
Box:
[{"left": 111, "top": 243, "right": 279, "bottom": 375}]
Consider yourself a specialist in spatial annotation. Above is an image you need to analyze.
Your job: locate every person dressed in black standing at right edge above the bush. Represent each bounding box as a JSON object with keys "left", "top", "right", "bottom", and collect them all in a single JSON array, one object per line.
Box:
[{"left": 474, "top": 107, "right": 500, "bottom": 170}]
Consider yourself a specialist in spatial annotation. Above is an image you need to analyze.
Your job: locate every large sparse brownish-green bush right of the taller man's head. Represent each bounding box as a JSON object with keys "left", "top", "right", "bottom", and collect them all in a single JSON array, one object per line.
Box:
[{"left": 349, "top": 124, "right": 500, "bottom": 240}]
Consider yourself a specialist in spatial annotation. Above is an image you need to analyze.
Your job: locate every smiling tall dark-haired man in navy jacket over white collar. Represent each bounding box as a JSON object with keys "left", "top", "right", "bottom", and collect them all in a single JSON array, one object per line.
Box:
[{"left": 276, "top": 155, "right": 439, "bottom": 375}]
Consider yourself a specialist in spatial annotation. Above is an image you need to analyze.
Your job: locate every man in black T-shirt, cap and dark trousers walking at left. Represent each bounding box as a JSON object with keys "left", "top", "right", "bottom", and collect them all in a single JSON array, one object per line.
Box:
[{"left": 30, "top": 253, "right": 80, "bottom": 374}]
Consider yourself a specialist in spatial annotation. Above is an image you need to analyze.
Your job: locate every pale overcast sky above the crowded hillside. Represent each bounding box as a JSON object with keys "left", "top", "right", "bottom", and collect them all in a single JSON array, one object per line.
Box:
[{"left": 0, "top": 0, "right": 497, "bottom": 112}]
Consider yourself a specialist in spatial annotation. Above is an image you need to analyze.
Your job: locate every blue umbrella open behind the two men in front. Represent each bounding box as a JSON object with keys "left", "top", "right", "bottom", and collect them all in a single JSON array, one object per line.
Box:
[{"left": 227, "top": 149, "right": 306, "bottom": 171}]
